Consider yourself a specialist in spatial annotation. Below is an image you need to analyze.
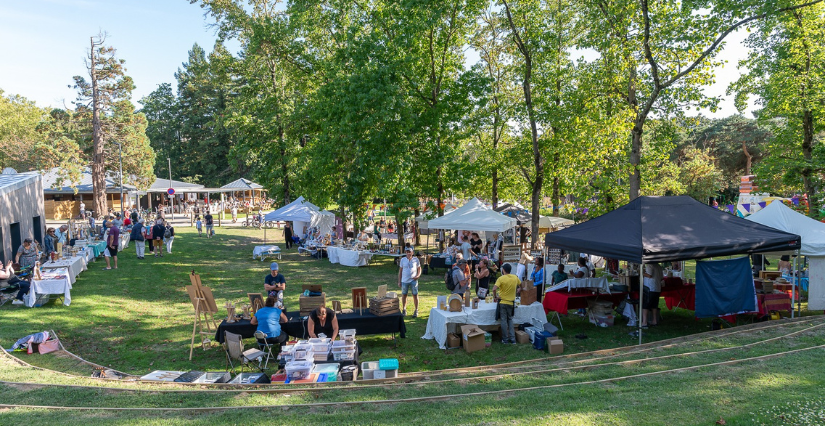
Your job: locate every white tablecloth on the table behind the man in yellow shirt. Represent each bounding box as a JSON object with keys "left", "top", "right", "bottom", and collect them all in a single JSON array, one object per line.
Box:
[{"left": 421, "top": 301, "right": 547, "bottom": 349}]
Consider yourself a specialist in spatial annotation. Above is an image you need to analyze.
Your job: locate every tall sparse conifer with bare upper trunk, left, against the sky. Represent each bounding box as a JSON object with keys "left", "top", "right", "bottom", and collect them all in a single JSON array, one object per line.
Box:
[{"left": 74, "top": 35, "right": 155, "bottom": 213}]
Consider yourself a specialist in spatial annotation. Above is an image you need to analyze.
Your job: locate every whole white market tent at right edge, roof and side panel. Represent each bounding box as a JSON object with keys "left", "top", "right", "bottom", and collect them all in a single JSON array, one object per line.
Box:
[{"left": 746, "top": 201, "right": 825, "bottom": 310}]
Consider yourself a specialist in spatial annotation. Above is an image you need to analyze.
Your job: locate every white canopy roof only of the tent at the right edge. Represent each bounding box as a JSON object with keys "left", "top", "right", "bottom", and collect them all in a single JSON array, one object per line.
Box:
[{"left": 746, "top": 201, "right": 825, "bottom": 256}]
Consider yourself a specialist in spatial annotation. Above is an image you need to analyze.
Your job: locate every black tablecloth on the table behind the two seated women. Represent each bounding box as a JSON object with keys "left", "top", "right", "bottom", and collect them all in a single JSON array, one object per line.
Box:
[{"left": 215, "top": 311, "right": 407, "bottom": 343}]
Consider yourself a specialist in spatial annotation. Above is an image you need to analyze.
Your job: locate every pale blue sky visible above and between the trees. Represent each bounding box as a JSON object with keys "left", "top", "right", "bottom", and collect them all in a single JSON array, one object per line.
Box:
[{"left": 0, "top": 0, "right": 747, "bottom": 117}]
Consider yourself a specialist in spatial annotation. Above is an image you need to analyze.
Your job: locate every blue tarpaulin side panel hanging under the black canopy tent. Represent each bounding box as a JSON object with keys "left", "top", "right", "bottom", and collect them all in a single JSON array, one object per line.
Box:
[{"left": 696, "top": 257, "right": 756, "bottom": 318}]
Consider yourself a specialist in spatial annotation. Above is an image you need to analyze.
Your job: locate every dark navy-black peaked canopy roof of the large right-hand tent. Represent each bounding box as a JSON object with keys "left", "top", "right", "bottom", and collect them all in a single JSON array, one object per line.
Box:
[{"left": 545, "top": 196, "right": 800, "bottom": 263}]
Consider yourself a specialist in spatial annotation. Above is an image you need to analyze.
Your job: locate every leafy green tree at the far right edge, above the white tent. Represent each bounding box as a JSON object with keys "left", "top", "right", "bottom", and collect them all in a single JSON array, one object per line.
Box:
[{"left": 729, "top": 2, "right": 825, "bottom": 216}]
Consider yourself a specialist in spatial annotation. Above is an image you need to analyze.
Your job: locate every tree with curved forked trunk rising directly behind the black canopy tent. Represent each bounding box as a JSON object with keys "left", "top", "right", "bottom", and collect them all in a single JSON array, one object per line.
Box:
[{"left": 582, "top": 0, "right": 821, "bottom": 199}]
